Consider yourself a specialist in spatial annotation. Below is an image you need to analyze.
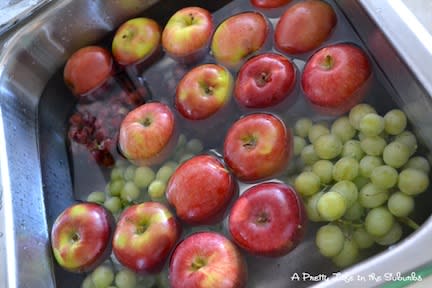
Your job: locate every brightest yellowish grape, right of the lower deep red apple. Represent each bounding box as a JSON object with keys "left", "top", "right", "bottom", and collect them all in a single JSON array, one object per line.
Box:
[{"left": 317, "top": 191, "right": 347, "bottom": 221}]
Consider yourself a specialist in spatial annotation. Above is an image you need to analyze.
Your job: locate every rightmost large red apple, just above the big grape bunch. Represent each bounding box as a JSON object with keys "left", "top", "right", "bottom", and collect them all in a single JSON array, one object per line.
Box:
[{"left": 301, "top": 43, "right": 372, "bottom": 115}]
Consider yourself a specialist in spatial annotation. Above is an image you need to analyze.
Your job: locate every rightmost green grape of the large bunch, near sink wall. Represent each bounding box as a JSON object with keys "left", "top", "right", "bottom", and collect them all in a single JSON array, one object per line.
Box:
[{"left": 398, "top": 168, "right": 429, "bottom": 196}]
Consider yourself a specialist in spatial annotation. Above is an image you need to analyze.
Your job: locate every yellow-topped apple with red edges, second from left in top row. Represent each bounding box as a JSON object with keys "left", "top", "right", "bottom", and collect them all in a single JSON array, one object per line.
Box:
[{"left": 112, "top": 17, "right": 161, "bottom": 66}]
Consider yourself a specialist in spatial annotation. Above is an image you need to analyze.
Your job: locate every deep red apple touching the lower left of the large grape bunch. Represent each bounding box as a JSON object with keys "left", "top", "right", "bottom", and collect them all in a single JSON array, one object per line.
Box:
[{"left": 228, "top": 182, "right": 306, "bottom": 257}]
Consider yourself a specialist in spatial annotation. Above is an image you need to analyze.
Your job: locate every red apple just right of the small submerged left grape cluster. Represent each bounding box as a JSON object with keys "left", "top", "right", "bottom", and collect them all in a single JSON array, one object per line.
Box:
[{"left": 166, "top": 155, "right": 237, "bottom": 225}]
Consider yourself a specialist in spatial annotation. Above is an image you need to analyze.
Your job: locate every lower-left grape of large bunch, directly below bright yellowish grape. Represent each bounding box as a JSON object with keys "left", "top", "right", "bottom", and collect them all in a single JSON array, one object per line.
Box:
[{"left": 315, "top": 224, "right": 345, "bottom": 257}]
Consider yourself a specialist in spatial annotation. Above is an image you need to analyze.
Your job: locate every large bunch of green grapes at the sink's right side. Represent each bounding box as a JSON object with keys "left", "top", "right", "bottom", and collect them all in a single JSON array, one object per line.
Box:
[{"left": 292, "top": 104, "right": 430, "bottom": 267}]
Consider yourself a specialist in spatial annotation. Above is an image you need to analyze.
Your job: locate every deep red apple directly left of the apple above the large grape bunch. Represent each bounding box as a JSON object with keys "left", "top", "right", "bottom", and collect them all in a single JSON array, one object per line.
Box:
[{"left": 234, "top": 53, "right": 296, "bottom": 108}]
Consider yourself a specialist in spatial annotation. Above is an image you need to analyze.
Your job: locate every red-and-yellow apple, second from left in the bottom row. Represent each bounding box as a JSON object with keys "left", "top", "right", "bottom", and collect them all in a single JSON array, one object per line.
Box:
[{"left": 113, "top": 202, "right": 181, "bottom": 274}]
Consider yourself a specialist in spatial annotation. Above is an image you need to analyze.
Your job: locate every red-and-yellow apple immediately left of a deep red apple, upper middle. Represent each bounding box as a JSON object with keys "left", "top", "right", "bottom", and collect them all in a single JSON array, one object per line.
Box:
[{"left": 175, "top": 64, "right": 233, "bottom": 120}]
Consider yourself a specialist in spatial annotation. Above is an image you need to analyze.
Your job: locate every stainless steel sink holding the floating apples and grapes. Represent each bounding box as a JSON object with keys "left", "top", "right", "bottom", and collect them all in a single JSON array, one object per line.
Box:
[{"left": 0, "top": 0, "right": 432, "bottom": 288}]
